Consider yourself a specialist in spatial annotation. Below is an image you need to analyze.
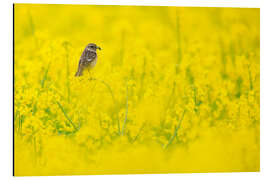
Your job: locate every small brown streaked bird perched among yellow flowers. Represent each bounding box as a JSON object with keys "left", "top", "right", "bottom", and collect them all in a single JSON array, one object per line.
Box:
[{"left": 75, "top": 43, "right": 101, "bottom": 76}]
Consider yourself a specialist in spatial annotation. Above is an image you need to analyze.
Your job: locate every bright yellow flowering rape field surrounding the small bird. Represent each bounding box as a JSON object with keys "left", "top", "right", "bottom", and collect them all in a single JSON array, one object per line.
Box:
[{"left": 14, "top": 4, "right": 260, "bottom": 176}]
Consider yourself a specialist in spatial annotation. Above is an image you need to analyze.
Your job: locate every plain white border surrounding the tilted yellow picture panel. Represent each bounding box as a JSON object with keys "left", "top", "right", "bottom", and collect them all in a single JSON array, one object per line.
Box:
[{"left": 0, "top": 0, "right": 270, "bottom": 180}]
